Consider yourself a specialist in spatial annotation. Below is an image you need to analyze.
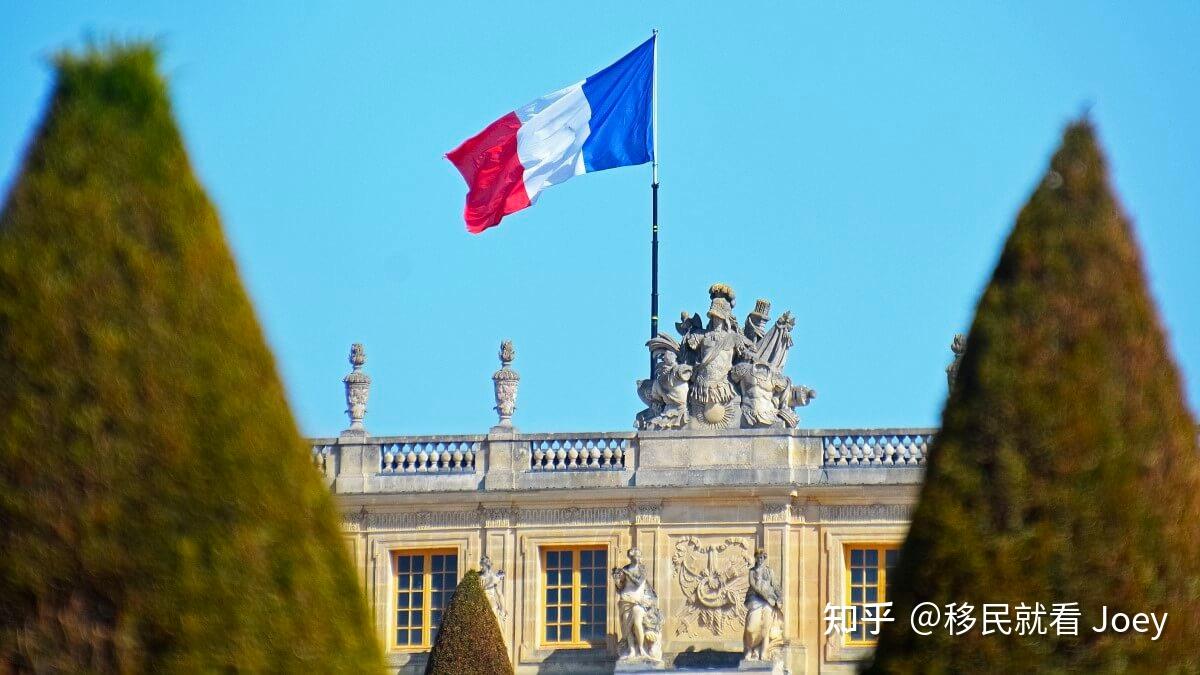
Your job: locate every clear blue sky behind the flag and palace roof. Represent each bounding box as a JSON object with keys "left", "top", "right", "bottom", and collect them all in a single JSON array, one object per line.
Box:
[{"left": 0, "top": 1, "right": 1200, "bottom": 435}]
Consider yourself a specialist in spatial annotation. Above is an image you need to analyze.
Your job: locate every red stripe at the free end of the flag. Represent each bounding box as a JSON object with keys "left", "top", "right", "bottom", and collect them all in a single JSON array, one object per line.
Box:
[{"left": 446, "top": 113, "right": 529, "bottom": 234}]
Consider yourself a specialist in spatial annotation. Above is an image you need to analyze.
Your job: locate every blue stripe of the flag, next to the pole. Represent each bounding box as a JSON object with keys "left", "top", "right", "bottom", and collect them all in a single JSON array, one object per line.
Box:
[{"left": 583, "top": 37, "right": 654, "bottom": 172}]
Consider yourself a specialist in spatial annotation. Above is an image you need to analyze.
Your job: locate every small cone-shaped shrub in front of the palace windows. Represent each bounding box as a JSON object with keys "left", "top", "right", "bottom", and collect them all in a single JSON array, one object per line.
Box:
[{"left": 425, "top": 569, "right": 512, "bottom": 675}]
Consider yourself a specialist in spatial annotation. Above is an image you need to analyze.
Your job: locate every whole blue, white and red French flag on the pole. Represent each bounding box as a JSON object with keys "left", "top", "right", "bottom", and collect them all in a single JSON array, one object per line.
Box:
[{"left": 446, "top": 37, "right": 655, "bottom": 234}]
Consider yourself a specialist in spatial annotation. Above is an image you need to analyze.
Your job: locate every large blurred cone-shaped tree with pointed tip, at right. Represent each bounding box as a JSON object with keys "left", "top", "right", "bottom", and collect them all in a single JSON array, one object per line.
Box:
[{"left": 871, "top": 120, "right": 1200, "bottom": 673}]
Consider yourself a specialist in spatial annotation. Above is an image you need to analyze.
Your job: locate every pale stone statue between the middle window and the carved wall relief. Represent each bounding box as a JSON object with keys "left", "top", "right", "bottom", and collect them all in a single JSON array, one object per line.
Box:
[{"left": 612, "top": 548, "right": 662, "bottom": 663}]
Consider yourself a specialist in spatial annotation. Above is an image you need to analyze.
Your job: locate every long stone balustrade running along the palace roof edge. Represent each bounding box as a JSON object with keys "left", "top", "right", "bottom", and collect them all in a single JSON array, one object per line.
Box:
[{"left": 304, "top": 428, "right": 936, "bottom": 494}]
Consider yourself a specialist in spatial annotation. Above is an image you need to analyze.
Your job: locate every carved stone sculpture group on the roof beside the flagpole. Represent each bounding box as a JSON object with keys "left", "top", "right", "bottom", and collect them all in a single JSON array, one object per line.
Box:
[{"left": 635, "top": 283, "right": 816, "bottom": 429}]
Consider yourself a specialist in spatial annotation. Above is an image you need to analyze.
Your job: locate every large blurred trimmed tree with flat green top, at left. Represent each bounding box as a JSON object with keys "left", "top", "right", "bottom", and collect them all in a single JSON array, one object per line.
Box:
[{"left": 0, "top": 46, "right": 382, "bottom": 673}]
